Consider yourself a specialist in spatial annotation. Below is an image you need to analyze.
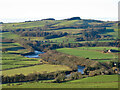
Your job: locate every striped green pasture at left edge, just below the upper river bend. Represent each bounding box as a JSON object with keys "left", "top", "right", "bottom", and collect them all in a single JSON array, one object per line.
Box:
[{"left": 2, "top": 53, "right": 40, "bottom": 70}]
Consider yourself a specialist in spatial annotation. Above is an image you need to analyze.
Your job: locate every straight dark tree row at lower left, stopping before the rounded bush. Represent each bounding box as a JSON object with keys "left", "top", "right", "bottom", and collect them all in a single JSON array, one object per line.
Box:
[{"left": 1, "top": 73, "right": 57, "bottom": 84}]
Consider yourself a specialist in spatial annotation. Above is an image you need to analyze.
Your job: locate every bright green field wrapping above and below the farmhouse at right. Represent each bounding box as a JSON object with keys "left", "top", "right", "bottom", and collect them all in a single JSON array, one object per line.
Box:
[{"left": 57, "top": 47, "right": 117, "bottom": 59}]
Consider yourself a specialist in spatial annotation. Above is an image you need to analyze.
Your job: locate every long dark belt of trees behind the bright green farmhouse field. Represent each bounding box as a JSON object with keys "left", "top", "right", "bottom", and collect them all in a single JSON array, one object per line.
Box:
[{"left": 30, "top": 40, "right": 120, "bottom": 51}]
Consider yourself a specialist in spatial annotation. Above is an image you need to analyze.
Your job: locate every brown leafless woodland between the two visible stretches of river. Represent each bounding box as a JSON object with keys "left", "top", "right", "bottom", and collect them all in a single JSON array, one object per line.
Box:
[{"left": 40, "top": 50, "right": 101, "bottom": 70}]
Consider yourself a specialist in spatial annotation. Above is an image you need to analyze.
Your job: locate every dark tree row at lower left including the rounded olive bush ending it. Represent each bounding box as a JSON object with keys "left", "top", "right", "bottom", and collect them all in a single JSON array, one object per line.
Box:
[{"left": 1, "top": 71, "right": 75, "bottom": 84}]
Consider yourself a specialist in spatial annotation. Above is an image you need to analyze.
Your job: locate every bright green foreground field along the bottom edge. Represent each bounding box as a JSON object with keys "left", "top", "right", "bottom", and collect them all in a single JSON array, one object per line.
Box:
[{"left": 3, "top": 75, "right": 118, "bottom": 88}]
